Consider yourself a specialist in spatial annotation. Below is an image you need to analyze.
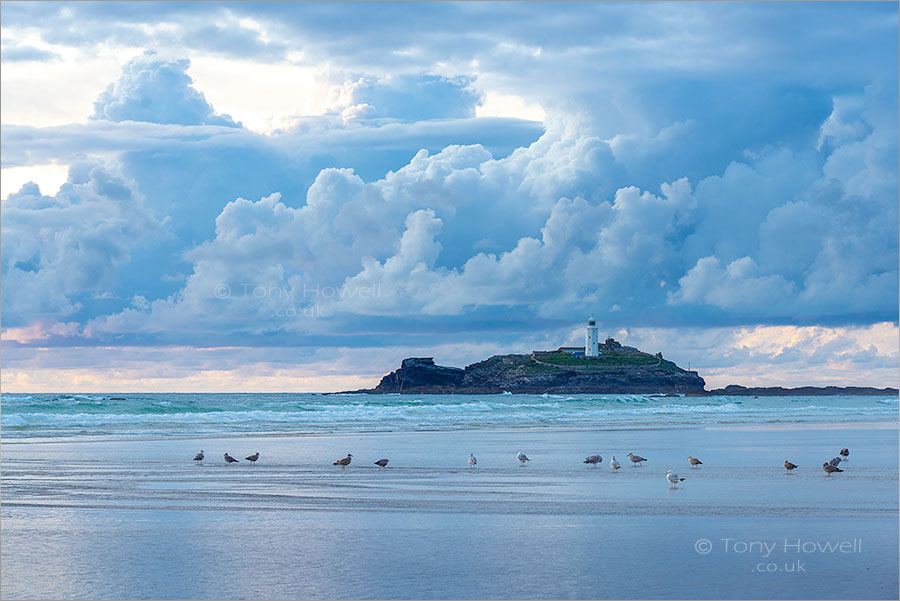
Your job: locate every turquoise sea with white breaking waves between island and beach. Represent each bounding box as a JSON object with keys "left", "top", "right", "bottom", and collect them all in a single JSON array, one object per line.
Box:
[{"left": 0, "top": 393, "right": 898, "bottom": 439}]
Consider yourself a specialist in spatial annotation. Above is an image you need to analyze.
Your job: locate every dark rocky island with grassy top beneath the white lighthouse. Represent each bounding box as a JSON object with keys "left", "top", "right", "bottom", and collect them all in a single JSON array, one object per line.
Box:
[{"left": 356, "top": 338, "right": 705, "bottom": 394}]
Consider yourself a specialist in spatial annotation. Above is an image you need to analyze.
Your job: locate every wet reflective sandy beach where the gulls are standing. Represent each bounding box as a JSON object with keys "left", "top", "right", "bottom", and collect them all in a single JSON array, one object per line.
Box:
[{"left": 2, "top": 418, "right": 898, "bottom": 599}]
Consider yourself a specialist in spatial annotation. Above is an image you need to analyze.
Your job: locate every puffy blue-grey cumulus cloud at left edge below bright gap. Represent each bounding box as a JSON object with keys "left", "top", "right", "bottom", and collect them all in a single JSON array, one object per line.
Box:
[{"left": 2, "top": 165, "right": 164, "bottom": 325}]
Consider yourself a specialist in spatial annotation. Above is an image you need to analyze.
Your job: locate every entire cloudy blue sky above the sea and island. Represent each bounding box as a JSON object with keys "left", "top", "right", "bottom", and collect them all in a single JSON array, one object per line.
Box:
[{"left": 0, "top": 2, "right": 900, "bottom": 392}]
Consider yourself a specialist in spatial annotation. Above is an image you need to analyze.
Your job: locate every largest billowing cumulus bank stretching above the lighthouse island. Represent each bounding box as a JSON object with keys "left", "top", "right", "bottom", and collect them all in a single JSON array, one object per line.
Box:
[{"left": 74, "top": 86, "right": 897, "bottom": 344}]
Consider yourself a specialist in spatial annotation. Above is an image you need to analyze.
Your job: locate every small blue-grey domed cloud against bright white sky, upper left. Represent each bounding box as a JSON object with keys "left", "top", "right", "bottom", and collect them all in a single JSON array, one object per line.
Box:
[{"left": 92, "top": 50, "right": 240, "bottom": 127}]
